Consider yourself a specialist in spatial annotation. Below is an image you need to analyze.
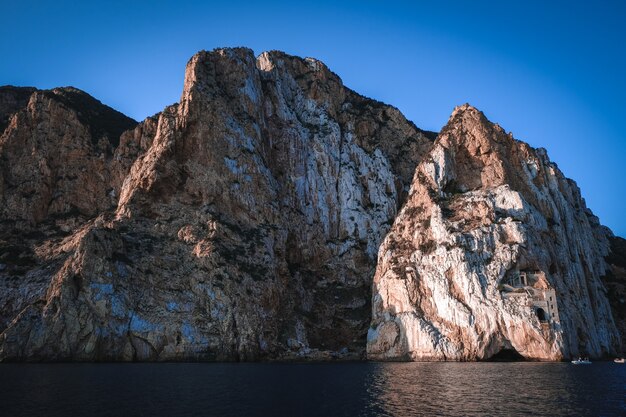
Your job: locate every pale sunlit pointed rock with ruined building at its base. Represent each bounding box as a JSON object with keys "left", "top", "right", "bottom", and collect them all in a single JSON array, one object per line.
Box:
[{"left": 367, "top": 105, "right": 620, "bottom": 360}]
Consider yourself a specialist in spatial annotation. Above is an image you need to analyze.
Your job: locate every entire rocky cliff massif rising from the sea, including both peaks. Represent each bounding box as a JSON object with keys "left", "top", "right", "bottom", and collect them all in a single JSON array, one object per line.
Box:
[{"left": 0, "top": 48, "right": 622, "bottom": 360}]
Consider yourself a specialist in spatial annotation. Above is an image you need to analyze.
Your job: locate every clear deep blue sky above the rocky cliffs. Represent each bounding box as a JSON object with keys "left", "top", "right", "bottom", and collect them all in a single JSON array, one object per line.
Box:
[{"left": 0, "top": 0, "right": 626, "bottom": 236}]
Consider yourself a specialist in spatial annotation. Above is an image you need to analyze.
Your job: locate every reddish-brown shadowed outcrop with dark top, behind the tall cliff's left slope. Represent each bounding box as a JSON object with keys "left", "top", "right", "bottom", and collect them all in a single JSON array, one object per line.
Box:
[{"left": 0, "top": 86, "right": 136, "bottom": 338}]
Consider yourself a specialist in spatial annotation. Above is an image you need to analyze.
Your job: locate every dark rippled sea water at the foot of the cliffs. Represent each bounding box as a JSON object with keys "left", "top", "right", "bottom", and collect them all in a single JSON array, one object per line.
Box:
[{"left": 0, "top": 362, "right": 626, "bottom": 417}]
